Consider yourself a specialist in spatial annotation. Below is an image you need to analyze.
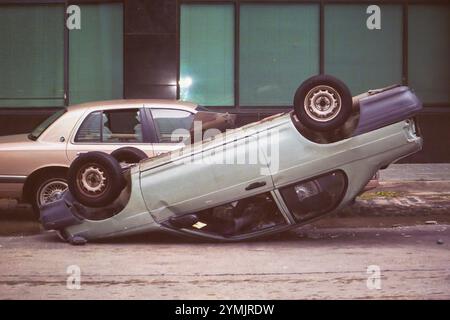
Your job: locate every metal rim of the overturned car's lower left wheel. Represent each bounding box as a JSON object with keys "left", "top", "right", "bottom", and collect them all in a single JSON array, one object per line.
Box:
[{"left": 77, "top": 164, "right": 109, "bottom": 197}]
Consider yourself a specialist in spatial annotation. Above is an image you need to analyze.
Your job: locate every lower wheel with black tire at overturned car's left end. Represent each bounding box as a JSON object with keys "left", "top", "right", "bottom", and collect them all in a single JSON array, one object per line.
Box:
[{"left": 68, "top": 151, "right": 125, "bottom": 208}]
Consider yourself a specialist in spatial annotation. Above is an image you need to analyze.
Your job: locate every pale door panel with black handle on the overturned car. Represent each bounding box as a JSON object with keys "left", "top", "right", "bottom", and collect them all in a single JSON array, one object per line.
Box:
[{"left": 141, "top": 124, "right": 273, "bottom": 222}]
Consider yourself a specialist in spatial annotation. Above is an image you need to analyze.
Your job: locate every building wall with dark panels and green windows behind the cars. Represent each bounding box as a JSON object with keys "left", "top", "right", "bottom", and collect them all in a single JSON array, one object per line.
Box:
[{"left": 0, "top": 0, "right": 450, "bottom": 162}]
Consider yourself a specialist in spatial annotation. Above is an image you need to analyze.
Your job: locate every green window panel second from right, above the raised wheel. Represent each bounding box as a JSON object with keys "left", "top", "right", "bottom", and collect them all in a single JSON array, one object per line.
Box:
[{"left": 325, "top": 4, "right": 403, "bottom": 95}]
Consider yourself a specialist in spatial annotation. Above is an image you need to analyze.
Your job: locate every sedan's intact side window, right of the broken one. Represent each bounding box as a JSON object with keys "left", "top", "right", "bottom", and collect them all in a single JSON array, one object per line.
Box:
[{"left": 151, "top": 109, "right": 194, "bottom": 143}]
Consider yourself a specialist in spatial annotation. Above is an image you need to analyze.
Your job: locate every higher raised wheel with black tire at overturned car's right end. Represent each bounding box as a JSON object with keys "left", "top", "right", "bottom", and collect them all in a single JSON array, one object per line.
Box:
[{"left": 294, "top": 75, "right": 352, "bottom": 132}]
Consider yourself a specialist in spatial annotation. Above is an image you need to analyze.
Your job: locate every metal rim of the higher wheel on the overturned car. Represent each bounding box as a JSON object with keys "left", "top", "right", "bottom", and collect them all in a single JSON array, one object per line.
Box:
[{"left": 304, "top": 86, "right": 342, "bottom": 122}]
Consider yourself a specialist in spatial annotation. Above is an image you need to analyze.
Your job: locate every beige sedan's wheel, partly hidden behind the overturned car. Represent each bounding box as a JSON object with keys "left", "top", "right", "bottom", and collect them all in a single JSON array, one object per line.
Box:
[{"left": 30, "top": 170, "right": 67, "bottom": 217}]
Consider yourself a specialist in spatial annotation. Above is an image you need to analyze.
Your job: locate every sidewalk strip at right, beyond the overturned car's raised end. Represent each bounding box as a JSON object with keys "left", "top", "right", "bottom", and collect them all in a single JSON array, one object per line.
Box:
[{"left": 335, "top": 163, "right": 450, "bottom": 223}]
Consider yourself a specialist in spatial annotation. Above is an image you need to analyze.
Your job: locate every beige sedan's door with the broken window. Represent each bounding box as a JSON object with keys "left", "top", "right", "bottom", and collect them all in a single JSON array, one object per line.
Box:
[{"left": 67, "top": 106, "right": 154, "bottom": 161}]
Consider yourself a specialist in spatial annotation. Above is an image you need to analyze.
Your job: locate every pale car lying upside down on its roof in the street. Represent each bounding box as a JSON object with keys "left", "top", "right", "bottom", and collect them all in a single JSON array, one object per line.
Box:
[{"left": 40, "top": 75, "right": 422, "bottom": 244}]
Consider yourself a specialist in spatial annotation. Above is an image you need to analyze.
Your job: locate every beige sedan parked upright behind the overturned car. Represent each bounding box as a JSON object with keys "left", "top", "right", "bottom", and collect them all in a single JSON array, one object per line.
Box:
[{"left": 0, "top": 100, "right": 235, "bottom": 215}]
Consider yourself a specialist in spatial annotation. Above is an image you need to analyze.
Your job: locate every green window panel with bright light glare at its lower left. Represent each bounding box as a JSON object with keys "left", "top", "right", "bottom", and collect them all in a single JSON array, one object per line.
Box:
[{"left": 180, "top": 4, "right": 234, "bottom": 106}]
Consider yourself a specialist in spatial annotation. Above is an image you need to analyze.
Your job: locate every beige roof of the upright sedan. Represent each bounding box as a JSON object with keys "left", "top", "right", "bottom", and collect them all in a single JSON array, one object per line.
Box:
[{"left": 67, "top": 99, "right": 198, "bottom": 111}]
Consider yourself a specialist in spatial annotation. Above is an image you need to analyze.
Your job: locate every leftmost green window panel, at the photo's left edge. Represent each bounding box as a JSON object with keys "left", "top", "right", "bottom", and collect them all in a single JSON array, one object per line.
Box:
[{"left": 0, "top": 5, "right": 64, "bottom": 107}]
